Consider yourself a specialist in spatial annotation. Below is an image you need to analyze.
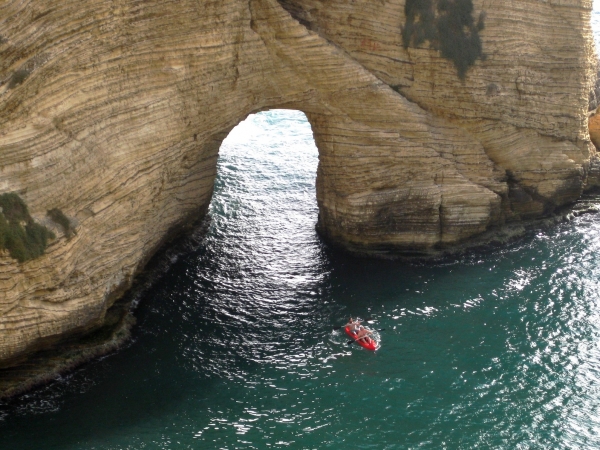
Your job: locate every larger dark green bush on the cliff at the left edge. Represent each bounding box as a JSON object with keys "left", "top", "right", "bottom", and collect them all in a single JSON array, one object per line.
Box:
[{"left": 0, "top": 192, "right": 55, "bottom": 262}]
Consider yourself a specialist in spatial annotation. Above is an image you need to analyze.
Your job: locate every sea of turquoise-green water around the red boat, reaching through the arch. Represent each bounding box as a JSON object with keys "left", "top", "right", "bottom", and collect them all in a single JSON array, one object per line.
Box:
[{"left": 0, "top": 14, "right": 600, "bottom": 450}]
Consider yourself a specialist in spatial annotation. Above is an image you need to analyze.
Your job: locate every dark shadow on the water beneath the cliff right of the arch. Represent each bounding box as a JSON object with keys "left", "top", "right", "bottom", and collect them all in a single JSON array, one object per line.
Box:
[{"left": 324, "top": 232, "right": 535, "bottom": 317}]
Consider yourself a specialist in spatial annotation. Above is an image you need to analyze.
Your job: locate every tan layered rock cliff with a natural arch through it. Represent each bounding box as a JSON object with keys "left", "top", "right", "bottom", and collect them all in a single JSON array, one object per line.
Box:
[{"left": 0, "top": 0, "right": 597, "bottom": 365}]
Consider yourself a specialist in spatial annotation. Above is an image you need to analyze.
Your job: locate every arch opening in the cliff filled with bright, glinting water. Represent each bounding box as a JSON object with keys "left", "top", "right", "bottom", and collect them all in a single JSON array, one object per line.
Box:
[{"left": 208, "top": 109, "right": 321, "bottom": 276}]
